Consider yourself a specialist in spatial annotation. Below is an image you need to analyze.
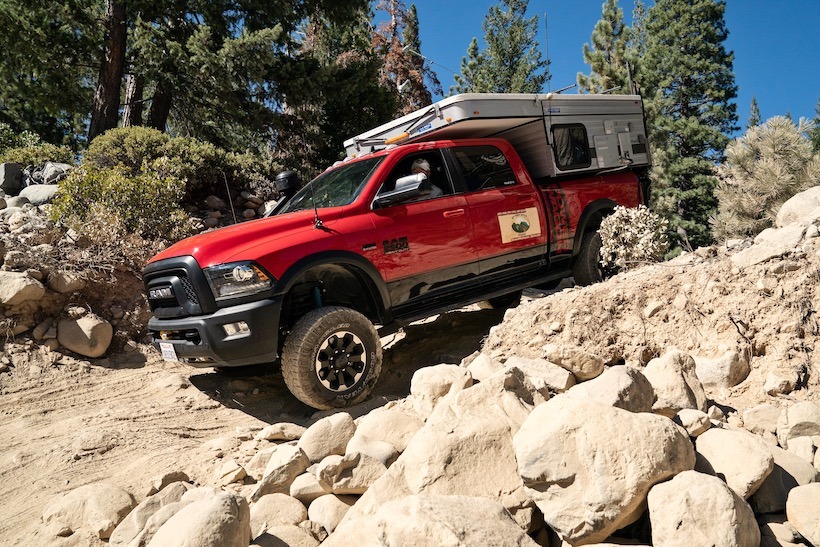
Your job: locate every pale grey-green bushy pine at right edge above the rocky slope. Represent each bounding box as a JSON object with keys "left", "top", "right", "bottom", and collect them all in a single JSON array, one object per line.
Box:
[{"left": 712, "top": 116, "right": 820, "bottom": 240}]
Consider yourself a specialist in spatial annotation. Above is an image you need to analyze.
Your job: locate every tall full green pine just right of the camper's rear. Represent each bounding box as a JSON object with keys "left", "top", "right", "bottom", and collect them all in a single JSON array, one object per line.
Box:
[{"left": 640, "top": 0, "right": 737, "bottom": 253}]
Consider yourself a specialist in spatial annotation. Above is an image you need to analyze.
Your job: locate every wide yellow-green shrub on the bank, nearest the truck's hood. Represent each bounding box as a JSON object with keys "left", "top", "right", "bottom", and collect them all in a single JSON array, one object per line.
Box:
[{"left": 51, "top": 164, "right": 191, "bottom": 241}]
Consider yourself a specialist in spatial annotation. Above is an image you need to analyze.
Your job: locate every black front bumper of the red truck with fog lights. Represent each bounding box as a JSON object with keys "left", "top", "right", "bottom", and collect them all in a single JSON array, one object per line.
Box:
[{"left": 148, "top": 299, "right": 282, "bottom": 367}]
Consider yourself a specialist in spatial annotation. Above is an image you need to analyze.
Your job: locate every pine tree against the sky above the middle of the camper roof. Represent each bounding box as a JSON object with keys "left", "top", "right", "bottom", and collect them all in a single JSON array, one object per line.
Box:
[{"left": 451, "top": 0, "right": 549, "bottom": 93}]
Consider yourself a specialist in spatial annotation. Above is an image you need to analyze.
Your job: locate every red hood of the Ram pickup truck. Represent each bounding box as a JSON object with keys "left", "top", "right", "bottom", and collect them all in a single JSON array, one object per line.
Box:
[{"left": 148, "top": 209, "right": 340, "bottom": 268}]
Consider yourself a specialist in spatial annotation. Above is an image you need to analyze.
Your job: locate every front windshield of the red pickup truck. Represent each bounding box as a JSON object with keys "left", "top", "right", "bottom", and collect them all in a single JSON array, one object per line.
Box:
[{"left": 280, "top": 157, "right": 383, "bottom": 214}]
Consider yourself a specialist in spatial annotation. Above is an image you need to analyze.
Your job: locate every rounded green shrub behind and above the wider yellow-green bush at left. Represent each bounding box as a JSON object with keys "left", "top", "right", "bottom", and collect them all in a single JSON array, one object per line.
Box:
[{"left": 83, "top": 127, "right": 170, "bottom": 174}]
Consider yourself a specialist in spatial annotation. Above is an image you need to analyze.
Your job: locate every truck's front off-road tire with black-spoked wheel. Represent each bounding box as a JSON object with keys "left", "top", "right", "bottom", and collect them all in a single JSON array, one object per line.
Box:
[{"left": 282, "top": 306, "right": 382, "bottom": 410}]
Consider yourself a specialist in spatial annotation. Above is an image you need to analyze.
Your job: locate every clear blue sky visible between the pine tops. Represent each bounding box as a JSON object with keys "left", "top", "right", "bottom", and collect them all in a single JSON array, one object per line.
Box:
[{"left": 406, "top": 0, "right": 820, "bottom": 133}]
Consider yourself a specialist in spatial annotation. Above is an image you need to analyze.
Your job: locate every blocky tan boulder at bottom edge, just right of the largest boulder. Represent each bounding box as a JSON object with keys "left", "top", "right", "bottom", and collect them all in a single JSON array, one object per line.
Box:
[{"left": 647, "top": 471, "right": 760, "bottom": 547}]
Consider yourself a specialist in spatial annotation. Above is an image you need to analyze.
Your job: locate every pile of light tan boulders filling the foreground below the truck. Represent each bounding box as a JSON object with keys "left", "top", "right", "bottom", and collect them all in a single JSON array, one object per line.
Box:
[{"left": 43, "top": 358, "right": 820, "bottom": 547}]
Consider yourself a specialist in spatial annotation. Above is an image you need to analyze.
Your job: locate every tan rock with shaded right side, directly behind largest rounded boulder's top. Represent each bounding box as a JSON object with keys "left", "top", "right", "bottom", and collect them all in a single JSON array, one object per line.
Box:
[{"left": 567, "top": 366, "right": 655, "bottom": 412}]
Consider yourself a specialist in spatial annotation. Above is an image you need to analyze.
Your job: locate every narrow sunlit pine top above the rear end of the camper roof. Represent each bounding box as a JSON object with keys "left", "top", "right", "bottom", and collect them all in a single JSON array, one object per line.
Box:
[{"left": 577, "top": 0, "right": 631, "bottom": 93}]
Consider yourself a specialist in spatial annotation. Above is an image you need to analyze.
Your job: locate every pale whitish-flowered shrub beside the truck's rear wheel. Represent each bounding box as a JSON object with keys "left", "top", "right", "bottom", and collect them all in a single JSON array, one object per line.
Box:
[{"left": 598, "top": 205, "right": 669, "bottom": 270}]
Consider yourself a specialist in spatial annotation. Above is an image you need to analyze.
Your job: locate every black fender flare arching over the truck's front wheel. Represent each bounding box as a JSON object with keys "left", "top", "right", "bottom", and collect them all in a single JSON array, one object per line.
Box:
[{"left": 273, "top": 251, "right": 392, "bottom": 324}]
